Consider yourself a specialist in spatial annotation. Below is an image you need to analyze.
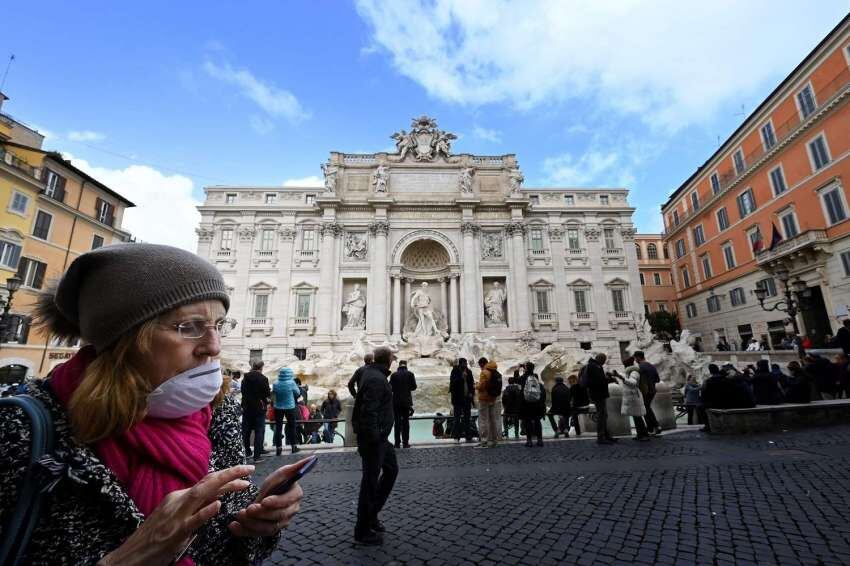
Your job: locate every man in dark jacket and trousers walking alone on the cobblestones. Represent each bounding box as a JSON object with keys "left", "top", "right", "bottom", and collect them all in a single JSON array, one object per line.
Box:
[{"left": 352, "top": 347, "right": 398, "bottom": 545}]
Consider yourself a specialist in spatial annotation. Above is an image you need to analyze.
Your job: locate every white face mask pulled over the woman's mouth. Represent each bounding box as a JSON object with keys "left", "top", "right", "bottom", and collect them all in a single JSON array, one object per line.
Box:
[{"left": 148, "top": 360, "right": 222, "bottom": 419}]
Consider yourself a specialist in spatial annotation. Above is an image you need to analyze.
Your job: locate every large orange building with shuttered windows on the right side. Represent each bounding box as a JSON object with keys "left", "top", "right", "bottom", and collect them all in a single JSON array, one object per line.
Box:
[{"left": 662, "top": 16, "right": 850, "bottom": 348}]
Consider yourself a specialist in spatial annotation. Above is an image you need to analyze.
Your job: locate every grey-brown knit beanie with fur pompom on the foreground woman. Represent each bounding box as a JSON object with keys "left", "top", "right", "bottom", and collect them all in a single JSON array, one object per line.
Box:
[{"left": 35, "top": 244, "right": 230, "bottom": 352}]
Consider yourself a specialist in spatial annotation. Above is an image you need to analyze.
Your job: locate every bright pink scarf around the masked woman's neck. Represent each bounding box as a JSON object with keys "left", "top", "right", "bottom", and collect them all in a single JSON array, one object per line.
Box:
[{"left": 50, "top": 346, "right": 212, "bottom": 544}]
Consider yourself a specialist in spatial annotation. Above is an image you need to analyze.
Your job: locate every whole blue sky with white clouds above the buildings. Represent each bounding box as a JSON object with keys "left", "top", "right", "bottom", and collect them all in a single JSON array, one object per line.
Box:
[{"left": 0, "top": 0, "right": 850, "bottom": 249}]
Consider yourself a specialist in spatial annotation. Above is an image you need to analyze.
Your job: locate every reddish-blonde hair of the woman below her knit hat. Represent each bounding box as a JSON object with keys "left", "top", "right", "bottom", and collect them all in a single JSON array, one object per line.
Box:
[{"left": 68, "top": 319, "right": 158, "bottom": 444}]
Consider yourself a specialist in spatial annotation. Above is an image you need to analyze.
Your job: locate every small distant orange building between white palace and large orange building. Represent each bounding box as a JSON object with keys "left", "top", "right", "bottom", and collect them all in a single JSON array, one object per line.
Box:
[{"left": 635, "top": 234, "right": 677, "bottom": 314}]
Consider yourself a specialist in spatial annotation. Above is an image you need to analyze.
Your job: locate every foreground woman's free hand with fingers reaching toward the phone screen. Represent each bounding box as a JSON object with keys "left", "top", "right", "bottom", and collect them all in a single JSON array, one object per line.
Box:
[{"left": 98, "top": 466, "right": 254, "bottom": 566}]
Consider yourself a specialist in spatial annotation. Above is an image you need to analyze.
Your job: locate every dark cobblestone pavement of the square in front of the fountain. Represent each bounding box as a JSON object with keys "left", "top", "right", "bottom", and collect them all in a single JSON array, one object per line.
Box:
[{"left": 252, "top": 426, "right": 850, "bottom": 566}]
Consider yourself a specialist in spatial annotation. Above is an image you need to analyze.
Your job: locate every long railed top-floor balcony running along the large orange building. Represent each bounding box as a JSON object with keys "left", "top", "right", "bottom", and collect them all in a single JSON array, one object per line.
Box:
[{"left": 661, "top": 68, "right": 850, "bottom": 238}]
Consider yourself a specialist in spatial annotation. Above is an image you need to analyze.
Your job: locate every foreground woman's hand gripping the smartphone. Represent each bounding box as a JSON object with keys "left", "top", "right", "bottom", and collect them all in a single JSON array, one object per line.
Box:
[{"left": 229, "top": 458, "right": 309, "bottom": 537}]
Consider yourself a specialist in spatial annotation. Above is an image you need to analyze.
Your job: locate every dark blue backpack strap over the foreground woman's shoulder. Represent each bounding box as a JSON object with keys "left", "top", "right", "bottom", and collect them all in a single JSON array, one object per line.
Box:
[{"left": 0, "top": 395, "right": 53, "bottom": 566}]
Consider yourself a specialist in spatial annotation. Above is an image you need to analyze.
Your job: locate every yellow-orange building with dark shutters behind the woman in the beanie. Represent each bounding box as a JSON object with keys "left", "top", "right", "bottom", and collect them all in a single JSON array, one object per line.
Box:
[{"left": 0, "top": 140, "right": 134, "bottom": 382}]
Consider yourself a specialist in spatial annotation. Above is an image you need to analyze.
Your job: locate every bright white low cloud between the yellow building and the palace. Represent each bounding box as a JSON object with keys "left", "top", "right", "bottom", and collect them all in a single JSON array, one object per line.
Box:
[{"left": 67, "top": 156, "right": 201, "bottom": 252}]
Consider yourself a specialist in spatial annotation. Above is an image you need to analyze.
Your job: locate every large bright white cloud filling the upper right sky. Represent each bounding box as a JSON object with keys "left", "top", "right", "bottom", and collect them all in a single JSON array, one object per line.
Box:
[{"left": 357, "top": 0, "right": 846, "bottom": 130}]
